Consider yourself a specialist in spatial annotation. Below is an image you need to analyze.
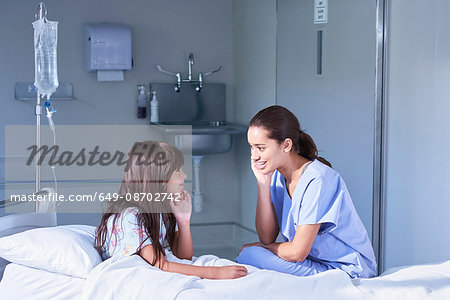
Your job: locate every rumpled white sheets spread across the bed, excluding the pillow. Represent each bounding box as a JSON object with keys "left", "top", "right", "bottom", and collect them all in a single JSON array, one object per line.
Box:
[{"left": 0, "top": 255, "right": 450, "bottom": 300}]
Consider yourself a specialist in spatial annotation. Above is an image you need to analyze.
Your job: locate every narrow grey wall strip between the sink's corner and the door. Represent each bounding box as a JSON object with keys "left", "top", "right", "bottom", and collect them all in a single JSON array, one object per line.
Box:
[{"left": 233, "top": 0, "right": 277, "bottom": 228}]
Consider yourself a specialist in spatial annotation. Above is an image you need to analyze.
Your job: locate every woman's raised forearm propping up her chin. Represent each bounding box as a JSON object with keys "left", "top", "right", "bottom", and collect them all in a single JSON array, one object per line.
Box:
[{"left": 252, "top": 179, "right": 280, "bottom": 244}]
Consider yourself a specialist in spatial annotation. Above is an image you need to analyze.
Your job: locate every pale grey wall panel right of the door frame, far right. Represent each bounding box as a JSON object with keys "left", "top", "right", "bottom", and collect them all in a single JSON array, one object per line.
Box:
[{"left": 384, "top": 0, "right": 450, "bottom": 268}]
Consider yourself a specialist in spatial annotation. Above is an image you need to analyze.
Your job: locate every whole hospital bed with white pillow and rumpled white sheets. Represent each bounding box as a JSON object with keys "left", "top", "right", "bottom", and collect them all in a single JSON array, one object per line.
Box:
[{"left": 0, "top": 214, "right": 450, "bottom": 300}]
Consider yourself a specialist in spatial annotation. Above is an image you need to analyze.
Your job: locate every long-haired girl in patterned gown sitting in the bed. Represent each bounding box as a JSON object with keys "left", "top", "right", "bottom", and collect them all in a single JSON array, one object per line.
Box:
[{"left": 95, "top": 141, "right": 247, "bottom": 279}]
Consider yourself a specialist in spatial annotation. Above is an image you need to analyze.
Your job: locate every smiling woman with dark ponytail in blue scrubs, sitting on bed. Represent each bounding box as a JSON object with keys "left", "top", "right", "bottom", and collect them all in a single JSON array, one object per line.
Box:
[{"left": 236, "top": 105, "right": 376, "bottom": 278}]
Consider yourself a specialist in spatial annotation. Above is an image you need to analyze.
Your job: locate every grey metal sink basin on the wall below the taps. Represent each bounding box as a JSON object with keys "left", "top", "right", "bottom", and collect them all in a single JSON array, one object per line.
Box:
[{"left": 152, "top": 121, "right": 247, "bottom": 156}]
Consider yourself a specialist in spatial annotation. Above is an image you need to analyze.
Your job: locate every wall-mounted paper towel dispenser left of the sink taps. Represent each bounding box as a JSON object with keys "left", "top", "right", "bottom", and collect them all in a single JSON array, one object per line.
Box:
[{"left": 84, "top": 23, "right": 132, "bottom": 81}]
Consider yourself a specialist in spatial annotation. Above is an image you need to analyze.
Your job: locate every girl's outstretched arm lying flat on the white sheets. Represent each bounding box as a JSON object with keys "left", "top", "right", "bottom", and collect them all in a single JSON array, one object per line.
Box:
[{"left": 139, "top": 245, "right": 247, "bottom": 279}]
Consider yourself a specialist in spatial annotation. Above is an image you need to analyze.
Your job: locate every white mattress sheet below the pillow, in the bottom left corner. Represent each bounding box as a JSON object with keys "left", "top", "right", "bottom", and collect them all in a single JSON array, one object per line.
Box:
[{"left": 0, "top": 263, "right": 84, "bottom": 300}]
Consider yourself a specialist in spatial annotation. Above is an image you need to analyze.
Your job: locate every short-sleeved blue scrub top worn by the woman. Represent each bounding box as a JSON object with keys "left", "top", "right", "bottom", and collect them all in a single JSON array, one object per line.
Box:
[{"left": 270, "top": 159, "right": 376, "bottom": 278}]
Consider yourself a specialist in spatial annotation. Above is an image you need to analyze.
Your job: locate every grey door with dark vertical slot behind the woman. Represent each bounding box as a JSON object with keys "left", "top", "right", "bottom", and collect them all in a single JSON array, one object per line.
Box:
[{"left": 277, "top": 0, "right": 376, "bottom": 236}]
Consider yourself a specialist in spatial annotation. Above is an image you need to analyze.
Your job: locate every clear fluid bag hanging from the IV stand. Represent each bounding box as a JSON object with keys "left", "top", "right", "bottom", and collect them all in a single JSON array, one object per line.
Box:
[{"left": 33, "top": 18, "right": 59, "bottom": 98}]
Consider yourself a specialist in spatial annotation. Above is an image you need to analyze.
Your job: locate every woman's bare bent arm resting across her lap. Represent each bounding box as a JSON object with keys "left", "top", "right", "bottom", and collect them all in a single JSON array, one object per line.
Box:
[{"left": 262, "top": 224, "right": 320, "bottom": 262}]
